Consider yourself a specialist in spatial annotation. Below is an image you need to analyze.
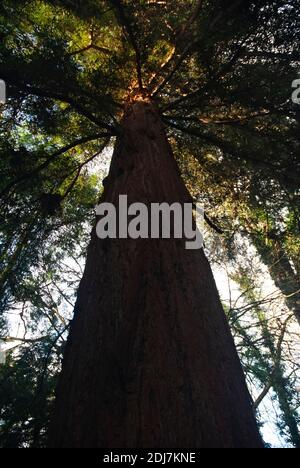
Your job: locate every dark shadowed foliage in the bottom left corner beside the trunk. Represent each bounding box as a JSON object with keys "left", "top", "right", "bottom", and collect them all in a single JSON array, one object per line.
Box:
[{"left": 0, "top": 336, "right": 61, "bottom": 448}]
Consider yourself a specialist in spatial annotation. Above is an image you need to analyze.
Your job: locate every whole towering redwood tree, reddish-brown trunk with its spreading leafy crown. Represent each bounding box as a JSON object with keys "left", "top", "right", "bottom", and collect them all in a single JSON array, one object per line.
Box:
[{"left": 0, "top": 0, "right": 299, "bottom": 448}]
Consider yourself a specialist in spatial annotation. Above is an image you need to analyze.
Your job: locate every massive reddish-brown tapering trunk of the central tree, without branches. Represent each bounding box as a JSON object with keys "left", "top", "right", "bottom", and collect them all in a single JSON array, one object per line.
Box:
[{"left": 49, "top": 101, "right": 262, "bottom": 448}]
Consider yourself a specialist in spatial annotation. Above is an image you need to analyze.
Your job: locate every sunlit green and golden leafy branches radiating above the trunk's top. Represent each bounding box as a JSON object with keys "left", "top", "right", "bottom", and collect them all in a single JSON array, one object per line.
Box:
[{"left": 0, "top": 0, "right": 299, "bottom": 191}]
